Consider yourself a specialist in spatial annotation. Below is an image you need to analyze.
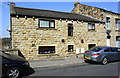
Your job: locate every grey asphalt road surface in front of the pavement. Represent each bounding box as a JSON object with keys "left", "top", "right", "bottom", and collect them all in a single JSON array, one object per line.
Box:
[{"left": 24, "top": 62, "right": 119, "bottom": 77}]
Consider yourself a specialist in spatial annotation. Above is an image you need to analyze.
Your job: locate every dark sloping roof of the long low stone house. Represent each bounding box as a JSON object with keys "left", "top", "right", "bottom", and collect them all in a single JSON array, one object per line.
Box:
[{"left": 11, "top": 7, "right": 103, "bottom": 23}]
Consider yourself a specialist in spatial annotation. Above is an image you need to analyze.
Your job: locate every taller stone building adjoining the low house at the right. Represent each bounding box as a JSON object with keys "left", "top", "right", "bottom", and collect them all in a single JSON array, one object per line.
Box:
[{"left": 72, "top": 2, "right": 120, "bottom": 47}]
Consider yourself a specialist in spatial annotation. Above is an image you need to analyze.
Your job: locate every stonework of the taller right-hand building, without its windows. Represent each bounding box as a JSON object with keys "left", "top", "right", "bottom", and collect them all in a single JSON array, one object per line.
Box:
[{"left": 72, "top": 2, "right": 120, "bottom": 47}]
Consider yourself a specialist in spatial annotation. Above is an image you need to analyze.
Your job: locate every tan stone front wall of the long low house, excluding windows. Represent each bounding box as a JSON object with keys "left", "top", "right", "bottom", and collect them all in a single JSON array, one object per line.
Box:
[{"left": 12, "top": 17, "right": 106, "bottom": 60}]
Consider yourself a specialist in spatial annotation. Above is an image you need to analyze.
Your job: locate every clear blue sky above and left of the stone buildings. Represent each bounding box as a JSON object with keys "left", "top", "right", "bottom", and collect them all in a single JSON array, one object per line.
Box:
[{"left": 0, "top": 2, "right": 118, "bottom": 38}]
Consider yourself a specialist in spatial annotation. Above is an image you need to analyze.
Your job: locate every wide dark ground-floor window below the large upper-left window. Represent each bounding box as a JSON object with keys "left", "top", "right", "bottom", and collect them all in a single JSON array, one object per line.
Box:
[{"left": 39, "top": 46, "right": 55, "bottom": 54}]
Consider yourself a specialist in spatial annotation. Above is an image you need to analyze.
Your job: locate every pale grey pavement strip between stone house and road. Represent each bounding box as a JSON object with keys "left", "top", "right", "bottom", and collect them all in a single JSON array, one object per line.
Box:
[{"left": 29, "top": 56, "right": 84, "bottom": 68}]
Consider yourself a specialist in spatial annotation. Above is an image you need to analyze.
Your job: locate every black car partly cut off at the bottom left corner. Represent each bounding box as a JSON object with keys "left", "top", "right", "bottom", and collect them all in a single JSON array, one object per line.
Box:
[{"left": 0, "top": 50, "right": 30, "bottom": 78}]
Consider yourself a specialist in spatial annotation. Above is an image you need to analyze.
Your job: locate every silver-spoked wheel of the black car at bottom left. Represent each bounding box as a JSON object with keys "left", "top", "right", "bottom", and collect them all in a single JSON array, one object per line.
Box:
[{"left": 6, "top": 67, "right": 20, "bottom": 78}]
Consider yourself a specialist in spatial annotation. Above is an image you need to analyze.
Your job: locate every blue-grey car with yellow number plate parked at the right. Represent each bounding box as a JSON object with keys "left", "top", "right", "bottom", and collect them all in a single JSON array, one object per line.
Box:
[{"left": 84, "top": 46, "right": 120, "bottom": 65}]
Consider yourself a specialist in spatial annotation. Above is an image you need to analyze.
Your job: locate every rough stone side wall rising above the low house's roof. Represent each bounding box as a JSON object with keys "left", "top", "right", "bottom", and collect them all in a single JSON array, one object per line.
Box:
[{"left": 72, "top": 2, "right": 105, "bottom": 20}]
